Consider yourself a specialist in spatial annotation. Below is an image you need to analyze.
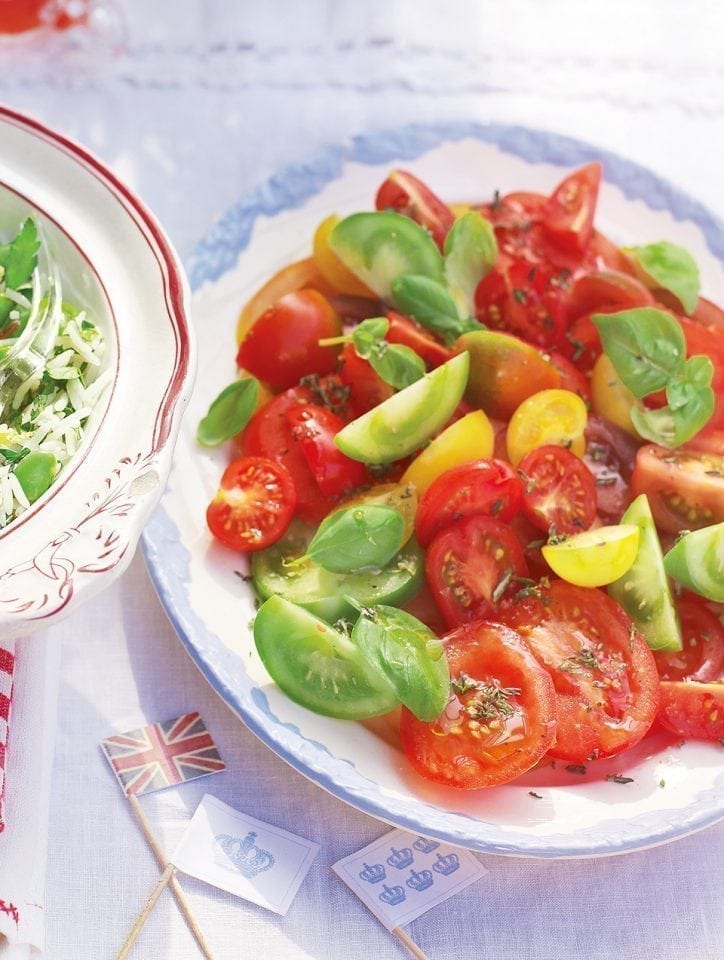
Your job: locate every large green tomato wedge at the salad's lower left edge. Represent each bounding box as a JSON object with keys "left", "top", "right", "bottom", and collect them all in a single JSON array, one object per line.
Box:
[{"left": 254, "top": 597, "right": 399, "bottom": 720}]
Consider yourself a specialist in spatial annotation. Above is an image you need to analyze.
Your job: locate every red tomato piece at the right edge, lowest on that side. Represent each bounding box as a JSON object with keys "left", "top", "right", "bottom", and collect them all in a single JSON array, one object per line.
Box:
[{"left": 658, "top": 680, "right": 724, "bottom": 741}]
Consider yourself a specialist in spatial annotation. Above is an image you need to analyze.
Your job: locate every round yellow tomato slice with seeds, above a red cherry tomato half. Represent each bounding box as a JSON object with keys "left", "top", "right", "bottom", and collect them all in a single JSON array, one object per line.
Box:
[{"left": 505, "top": 390, "right": 588, "bottom": 467}]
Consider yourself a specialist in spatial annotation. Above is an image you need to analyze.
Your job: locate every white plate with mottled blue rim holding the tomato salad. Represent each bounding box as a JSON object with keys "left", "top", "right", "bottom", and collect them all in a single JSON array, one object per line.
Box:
[{"left": 143, "top": 126, "right": 724, "bottom": 857}]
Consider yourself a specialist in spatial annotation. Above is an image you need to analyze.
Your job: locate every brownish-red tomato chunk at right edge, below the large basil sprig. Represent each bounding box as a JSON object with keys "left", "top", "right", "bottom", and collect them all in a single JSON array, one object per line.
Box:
[{"left": 631, "top": 443, "right": 724, "bottom": 533}]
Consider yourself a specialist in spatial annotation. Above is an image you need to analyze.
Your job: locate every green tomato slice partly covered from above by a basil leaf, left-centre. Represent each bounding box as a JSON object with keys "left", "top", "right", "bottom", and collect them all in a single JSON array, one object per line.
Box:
[{"left": 251, "top": 523, "right": 424, "bottom": 623}]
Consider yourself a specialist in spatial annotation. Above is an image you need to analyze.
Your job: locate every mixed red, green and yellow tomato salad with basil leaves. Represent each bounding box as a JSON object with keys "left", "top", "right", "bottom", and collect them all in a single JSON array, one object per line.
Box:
[{"left": 198, "top": 163, "right": 724, "bottom": 788}]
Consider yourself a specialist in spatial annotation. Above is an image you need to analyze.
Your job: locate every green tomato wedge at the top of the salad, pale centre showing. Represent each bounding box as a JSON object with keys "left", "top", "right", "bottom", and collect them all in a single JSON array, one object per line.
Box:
[{"left": 329, "top": 210, "right": 443, "bottom": 300}]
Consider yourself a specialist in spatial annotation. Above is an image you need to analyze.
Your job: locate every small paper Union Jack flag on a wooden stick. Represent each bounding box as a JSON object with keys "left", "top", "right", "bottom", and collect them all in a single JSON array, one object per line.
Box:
[{"left": 101, "top": 712, "right": 226, "bottom": 796}]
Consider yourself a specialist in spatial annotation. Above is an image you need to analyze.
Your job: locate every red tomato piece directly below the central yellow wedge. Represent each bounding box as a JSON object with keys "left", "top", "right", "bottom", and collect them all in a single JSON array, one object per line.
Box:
[{"left": 415, "top": 460, "right": 523, "bottom": 547}]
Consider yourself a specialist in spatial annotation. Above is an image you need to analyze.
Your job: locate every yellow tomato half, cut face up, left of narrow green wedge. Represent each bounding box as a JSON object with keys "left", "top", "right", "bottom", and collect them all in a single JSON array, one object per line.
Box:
[{"left": 542, "top": 523, "right": 640, "bottom": 587}]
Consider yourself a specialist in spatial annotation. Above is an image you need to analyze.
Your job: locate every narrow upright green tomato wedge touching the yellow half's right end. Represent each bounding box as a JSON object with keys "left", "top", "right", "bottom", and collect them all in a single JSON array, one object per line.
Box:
[{"left": 608, "top": 493, "right": 683, "bottom": 650}]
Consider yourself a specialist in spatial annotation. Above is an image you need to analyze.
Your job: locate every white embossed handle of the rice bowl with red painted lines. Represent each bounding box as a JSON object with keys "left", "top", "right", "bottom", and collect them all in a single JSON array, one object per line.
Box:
[{"left": 0, "top": 452, "right": 165, "bottom": 637}]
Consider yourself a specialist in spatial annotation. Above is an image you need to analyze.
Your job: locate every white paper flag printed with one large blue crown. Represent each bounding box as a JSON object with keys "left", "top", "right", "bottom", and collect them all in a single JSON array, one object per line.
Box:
[{"left": 170, "top": 794, "right": 319, "bottom": 914}]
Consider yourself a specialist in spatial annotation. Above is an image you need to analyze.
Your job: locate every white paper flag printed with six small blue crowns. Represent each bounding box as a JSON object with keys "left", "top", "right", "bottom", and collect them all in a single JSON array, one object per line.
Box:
[{"left": 332, "top": 830, "right": 488, "bottom": 930}]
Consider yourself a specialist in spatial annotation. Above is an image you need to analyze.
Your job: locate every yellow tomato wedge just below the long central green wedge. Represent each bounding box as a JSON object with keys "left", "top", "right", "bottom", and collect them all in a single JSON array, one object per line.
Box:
[{"left": 402, "top": 410, "right": 495, "bottom": 497}]
